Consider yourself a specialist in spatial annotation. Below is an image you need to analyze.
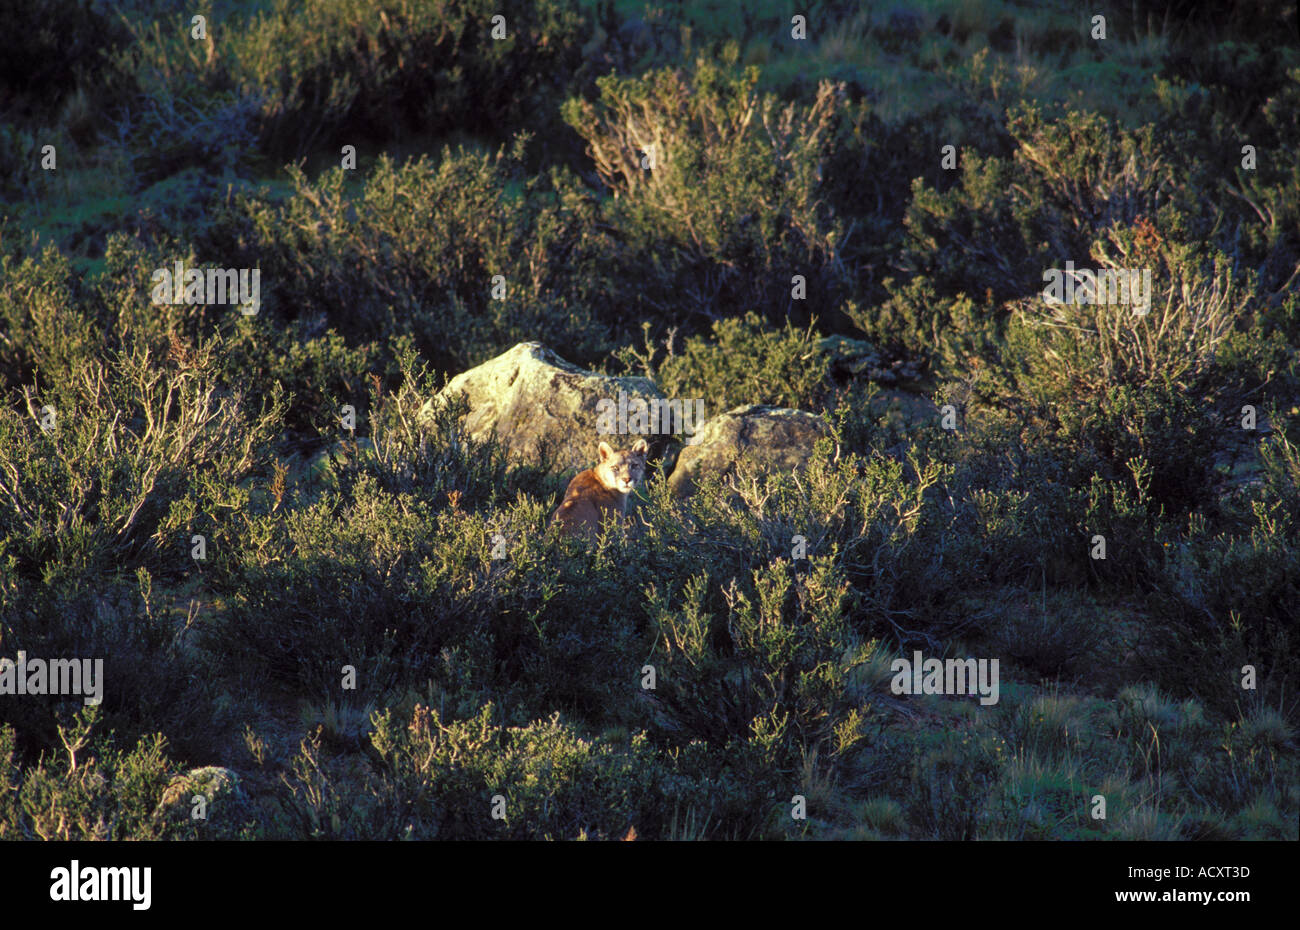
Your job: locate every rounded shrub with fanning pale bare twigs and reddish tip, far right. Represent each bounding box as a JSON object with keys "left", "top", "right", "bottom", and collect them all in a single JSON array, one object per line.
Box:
[{"left": 1004, "top": 224, "right": 1268, "bottom": 509}]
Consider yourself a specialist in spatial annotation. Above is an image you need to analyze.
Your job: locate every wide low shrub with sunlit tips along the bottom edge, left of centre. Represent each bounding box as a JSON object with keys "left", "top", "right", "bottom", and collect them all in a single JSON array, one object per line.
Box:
[{"left": 282, "top": 704, "right": 776, "bottom": 840}]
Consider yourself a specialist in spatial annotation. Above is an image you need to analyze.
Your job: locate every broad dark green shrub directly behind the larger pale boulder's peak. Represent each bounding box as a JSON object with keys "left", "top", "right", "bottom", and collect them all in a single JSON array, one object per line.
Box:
[{"left": 203, "top": 146, "right": 625, "bottom": 371}]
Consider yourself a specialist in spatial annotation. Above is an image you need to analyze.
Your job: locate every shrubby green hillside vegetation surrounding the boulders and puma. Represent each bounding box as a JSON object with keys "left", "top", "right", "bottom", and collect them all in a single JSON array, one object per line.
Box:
[{"left": 0, "top": 0, "right": 1300, "bottom": 840}]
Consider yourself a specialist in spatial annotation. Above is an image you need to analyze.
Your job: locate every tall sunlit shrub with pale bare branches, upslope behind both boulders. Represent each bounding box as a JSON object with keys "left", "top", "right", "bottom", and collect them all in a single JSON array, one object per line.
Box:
[{"left": 563, "top": 52, "right": 844, "bottom": 327}]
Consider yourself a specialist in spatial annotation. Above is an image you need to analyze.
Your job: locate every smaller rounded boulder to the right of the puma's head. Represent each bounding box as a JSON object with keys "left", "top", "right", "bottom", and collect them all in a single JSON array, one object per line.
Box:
[{"left": 668, "top": 405, "right": 831, "bottom": 497}]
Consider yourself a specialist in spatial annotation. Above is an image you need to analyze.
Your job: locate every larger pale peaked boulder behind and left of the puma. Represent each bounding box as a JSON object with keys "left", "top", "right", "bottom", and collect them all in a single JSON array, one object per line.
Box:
[{"left": 420, "top": 342, "right": 667, "bottom": 471}]
